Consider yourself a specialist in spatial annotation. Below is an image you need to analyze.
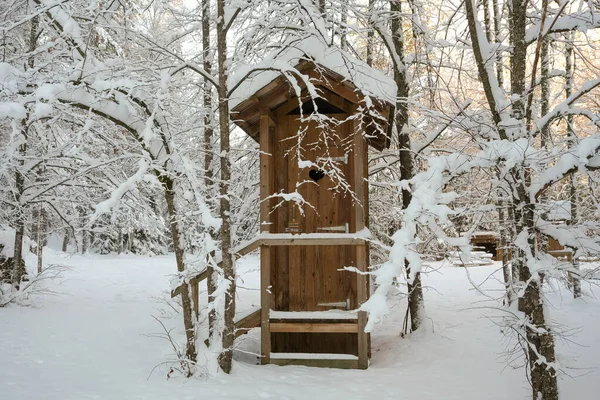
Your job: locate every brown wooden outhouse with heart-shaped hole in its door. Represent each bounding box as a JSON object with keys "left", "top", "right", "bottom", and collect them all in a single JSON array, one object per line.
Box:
[{"left": 231, "top": 59, "right": 395, "bottom": 368}]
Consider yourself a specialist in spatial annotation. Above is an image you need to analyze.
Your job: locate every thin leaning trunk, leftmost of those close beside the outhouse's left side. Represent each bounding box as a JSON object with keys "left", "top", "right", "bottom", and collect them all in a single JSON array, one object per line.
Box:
[{"left": 159, "top": 176, "right": 197, "bottom": 376}]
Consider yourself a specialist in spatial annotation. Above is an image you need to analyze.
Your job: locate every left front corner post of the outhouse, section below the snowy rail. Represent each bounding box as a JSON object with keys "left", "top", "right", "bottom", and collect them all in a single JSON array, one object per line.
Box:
[{"left": 260, "top": 246, "right": 271, "bottom": 364}]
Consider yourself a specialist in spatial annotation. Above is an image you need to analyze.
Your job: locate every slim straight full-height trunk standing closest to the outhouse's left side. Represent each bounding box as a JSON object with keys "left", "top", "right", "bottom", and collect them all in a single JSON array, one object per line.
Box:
[{"left": 217, "top": 0, "right": 235, "bottom": 373}]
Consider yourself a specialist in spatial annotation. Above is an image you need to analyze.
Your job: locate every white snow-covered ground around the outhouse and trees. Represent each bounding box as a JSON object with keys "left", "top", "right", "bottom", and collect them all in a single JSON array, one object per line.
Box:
[{"left": 0, "top": 250, "right": 600, "bottom": 400}]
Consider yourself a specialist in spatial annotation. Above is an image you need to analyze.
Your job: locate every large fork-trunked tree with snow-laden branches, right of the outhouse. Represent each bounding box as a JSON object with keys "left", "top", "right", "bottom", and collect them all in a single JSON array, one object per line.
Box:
[{"left": 465, "top": 0, "right": 600, "bottom": 400}]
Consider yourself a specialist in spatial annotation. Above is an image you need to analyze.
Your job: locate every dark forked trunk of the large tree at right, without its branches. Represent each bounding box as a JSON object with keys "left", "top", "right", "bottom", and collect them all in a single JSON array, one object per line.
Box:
[{"left": 465, "top": 0, "right": 558, "bottom": 400}]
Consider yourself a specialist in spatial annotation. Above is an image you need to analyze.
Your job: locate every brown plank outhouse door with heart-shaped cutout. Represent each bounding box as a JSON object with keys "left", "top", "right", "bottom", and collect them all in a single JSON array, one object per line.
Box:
[{"left": 286, "top": 116, "right": 356, "bottom": 311}]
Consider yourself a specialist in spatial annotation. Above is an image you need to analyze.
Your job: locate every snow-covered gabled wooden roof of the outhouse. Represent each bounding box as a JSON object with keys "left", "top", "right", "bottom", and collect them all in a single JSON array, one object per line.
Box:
[{"left": 228, "top": 39, "right": 396, "bottom": 150}]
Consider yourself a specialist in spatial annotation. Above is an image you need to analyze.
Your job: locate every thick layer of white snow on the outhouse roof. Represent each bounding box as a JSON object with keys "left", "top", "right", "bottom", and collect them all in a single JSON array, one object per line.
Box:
[{"left": 228, "top": 37, "right": 397, "bottom": 108}]
